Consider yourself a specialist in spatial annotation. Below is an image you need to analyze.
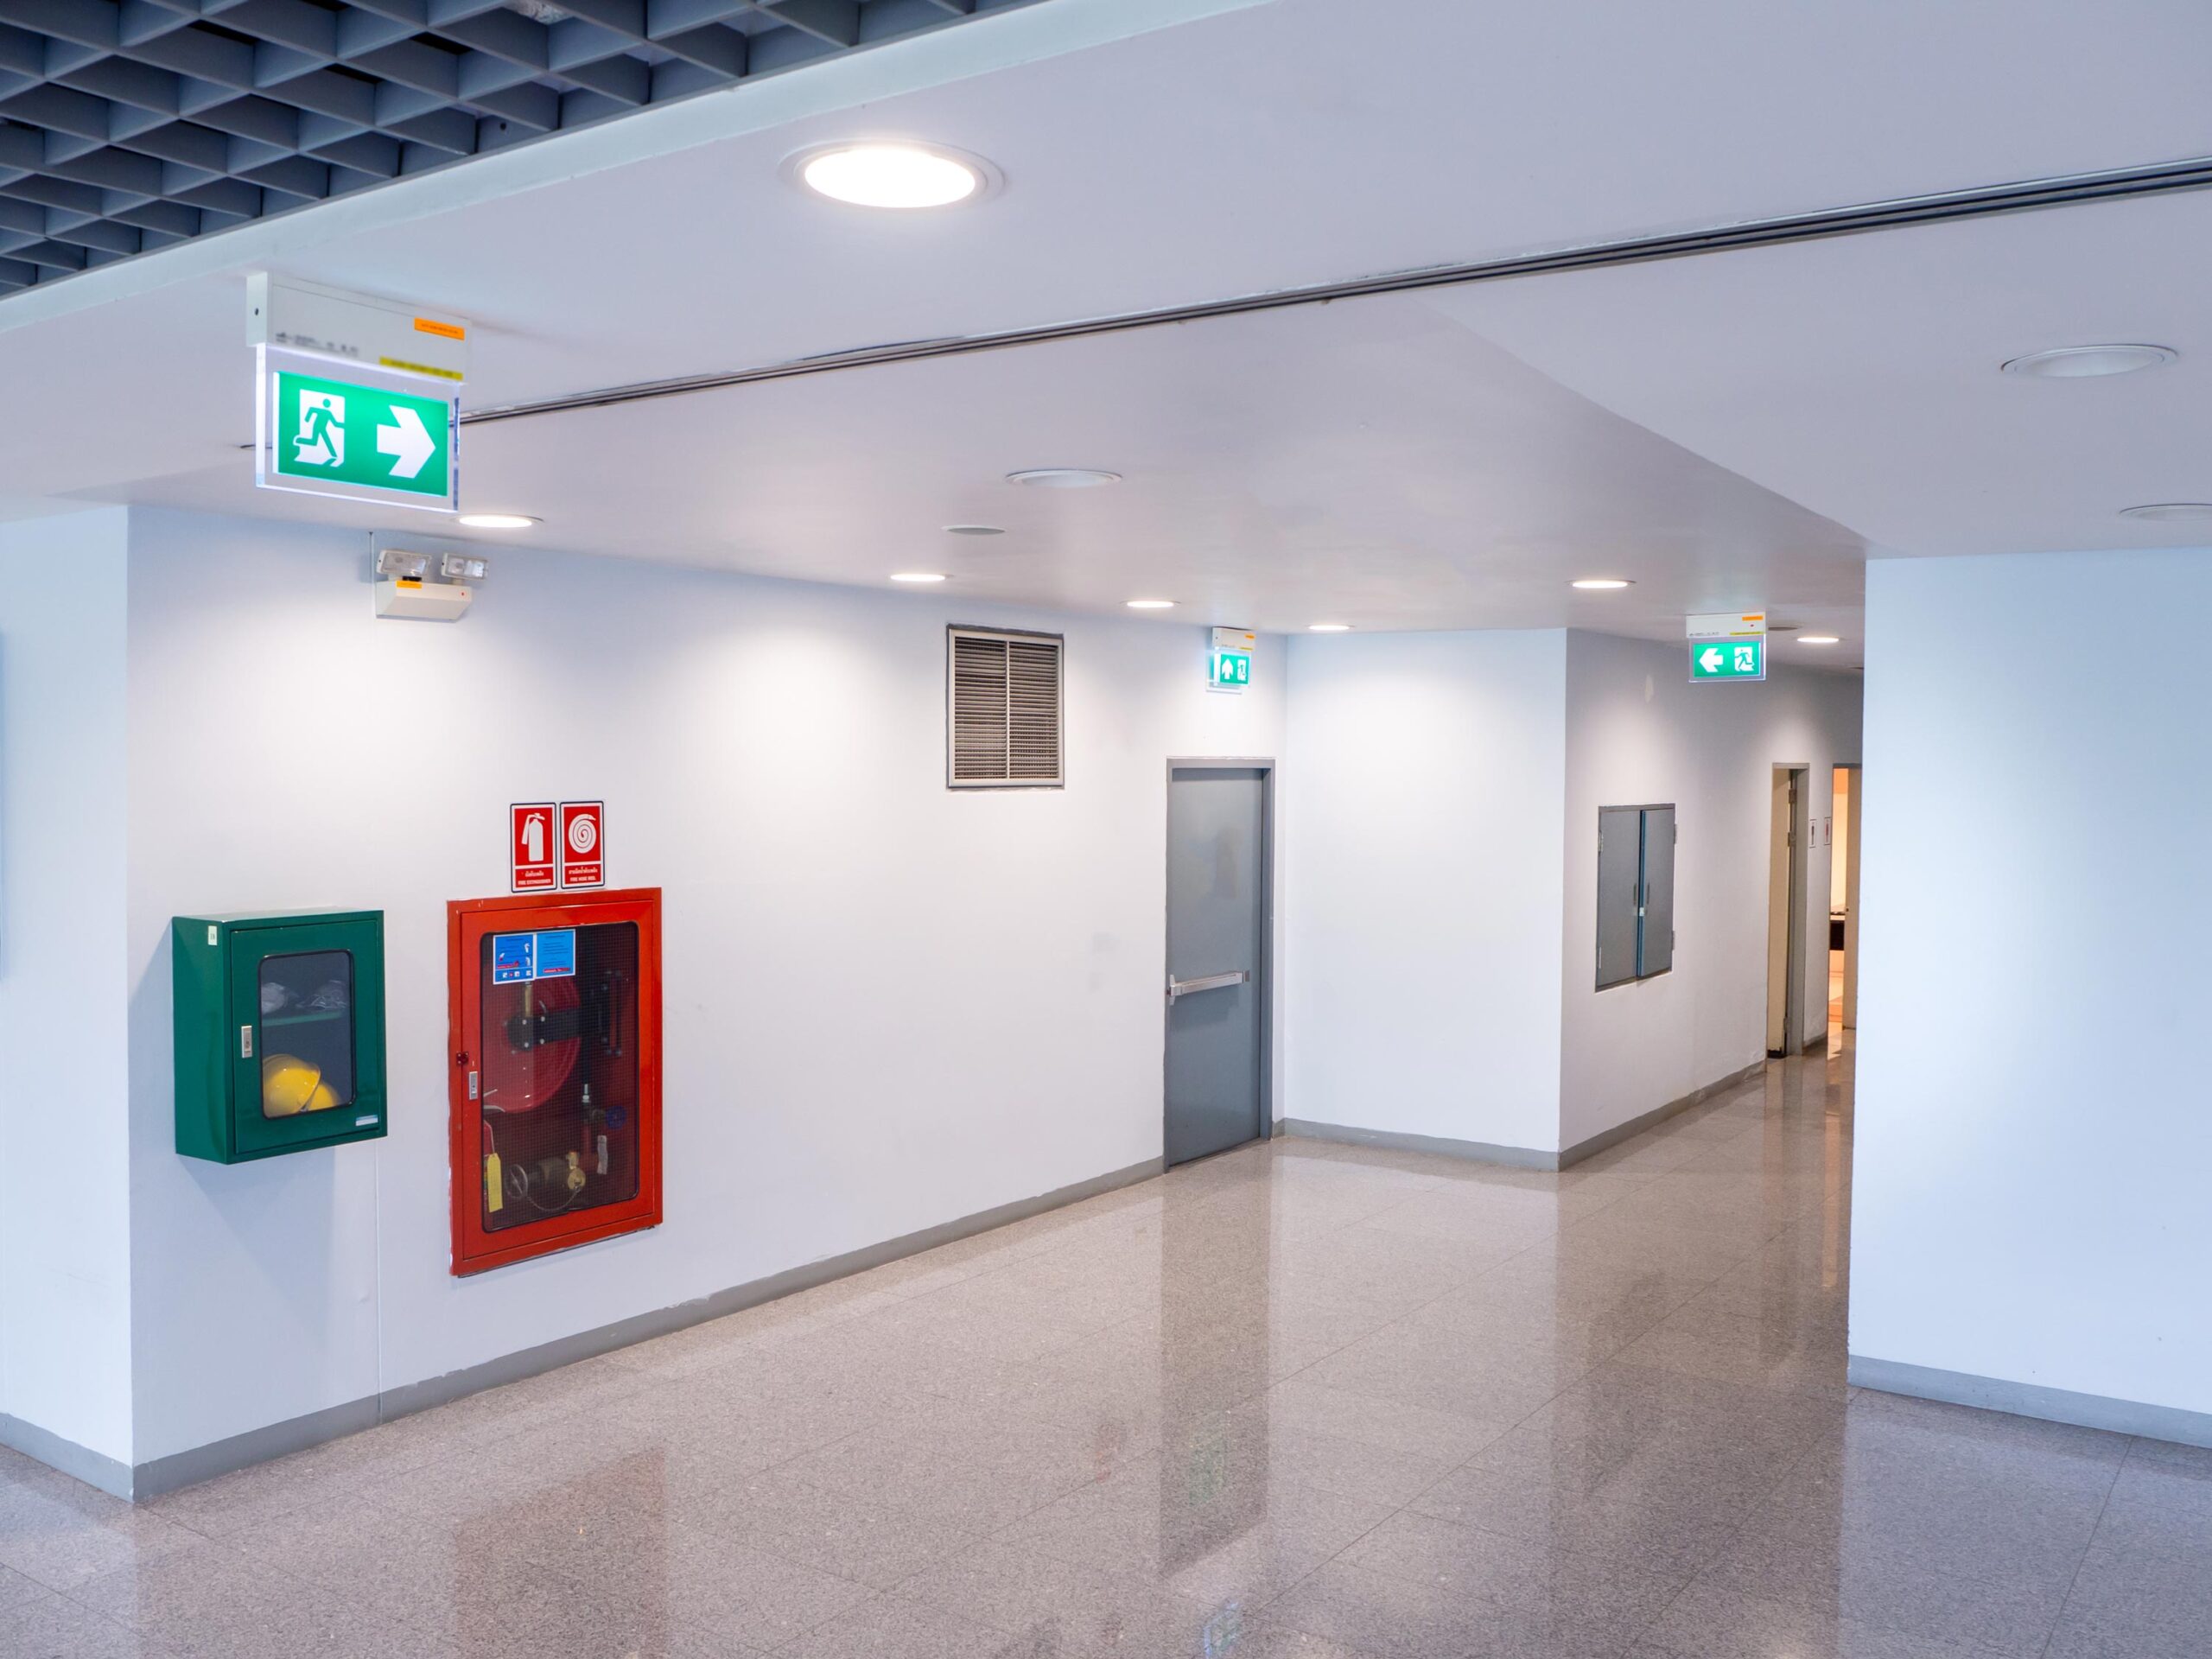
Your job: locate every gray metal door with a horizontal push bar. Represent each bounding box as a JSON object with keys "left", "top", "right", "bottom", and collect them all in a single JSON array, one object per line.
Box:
[{"left": 1166, "top": 766, "right": 1268, "bottom": 1164}]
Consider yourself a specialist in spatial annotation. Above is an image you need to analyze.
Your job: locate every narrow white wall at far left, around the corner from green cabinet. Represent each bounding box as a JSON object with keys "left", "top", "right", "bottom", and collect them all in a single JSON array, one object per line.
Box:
[{"left": 0, "top": 509, "right": 130, "bottom": 1465}]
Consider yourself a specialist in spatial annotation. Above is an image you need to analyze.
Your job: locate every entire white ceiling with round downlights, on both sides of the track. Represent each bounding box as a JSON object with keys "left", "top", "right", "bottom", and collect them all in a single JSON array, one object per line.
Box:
[{"left": 0, "top": 0, "right": 2212, "bottom": 661}]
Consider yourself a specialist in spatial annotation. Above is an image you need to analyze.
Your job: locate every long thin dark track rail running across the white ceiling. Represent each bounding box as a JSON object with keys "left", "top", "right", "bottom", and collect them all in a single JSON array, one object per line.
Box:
[{"left": 460, "top": 157, "right": 2212, "bottom": 425}]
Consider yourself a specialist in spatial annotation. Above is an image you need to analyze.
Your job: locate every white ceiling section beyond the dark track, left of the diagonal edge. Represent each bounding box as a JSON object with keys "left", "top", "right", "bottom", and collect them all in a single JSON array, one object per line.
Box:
[{"left": 129, "top": 296, "right": 1860, "bottom": 639}]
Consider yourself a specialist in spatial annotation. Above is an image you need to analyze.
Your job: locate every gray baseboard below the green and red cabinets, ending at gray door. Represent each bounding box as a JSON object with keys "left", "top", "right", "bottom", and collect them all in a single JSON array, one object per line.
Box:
[{"left": 35, "top": 1157, "right": 1166, "bottom": 1500}]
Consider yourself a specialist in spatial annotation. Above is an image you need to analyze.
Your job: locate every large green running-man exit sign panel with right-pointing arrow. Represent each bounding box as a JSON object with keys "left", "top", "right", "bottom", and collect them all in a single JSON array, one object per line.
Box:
[{"left": 259, "top": 367, "right": 458, "bottom": 511}]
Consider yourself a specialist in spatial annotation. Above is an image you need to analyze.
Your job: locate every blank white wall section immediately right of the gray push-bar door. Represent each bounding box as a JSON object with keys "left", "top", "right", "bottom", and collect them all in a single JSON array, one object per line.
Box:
[{"left": 1283, "top": 631, "right": 1566, "bottom": 1150}]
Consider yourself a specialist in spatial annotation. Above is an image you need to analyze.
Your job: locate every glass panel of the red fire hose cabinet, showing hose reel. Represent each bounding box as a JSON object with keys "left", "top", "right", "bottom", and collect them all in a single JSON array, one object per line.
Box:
[{"left": 478, "top": 923, "right": 637, "bottom": 1232}]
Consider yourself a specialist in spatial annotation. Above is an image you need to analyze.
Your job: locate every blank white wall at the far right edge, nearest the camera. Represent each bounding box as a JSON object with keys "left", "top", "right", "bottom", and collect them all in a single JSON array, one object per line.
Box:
[{"left": 1852, "top": 550, "right": 2212, "bottom": 1411}]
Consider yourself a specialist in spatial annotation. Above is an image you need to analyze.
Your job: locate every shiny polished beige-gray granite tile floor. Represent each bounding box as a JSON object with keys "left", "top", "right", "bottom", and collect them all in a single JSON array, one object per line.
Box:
[{"left": 0, "top": 1055, "right": 2212, "bottom": 1659}]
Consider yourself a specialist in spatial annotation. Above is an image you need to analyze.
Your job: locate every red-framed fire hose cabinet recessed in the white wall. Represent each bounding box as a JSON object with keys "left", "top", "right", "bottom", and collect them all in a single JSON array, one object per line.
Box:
[{"left": 447, "top": 887, "right": 661, "bottom": 1274}]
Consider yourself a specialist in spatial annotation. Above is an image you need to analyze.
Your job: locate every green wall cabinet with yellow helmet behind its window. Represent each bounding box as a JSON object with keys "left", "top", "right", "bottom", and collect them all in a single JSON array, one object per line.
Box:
[{"left": 170, "top": 909, "right": 385, "bottom": 1164}]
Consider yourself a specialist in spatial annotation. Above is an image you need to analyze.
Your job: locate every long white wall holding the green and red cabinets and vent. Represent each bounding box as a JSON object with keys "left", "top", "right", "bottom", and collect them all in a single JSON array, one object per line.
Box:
[{"left": 128, "top": 513, "right": 1283, "bottom": 1460}]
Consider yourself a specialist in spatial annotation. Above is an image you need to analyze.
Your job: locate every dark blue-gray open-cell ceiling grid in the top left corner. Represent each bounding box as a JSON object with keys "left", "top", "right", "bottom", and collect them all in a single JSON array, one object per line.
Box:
[{"left": 0, "top": 0, "right": 1033, "bottom": 296}]
